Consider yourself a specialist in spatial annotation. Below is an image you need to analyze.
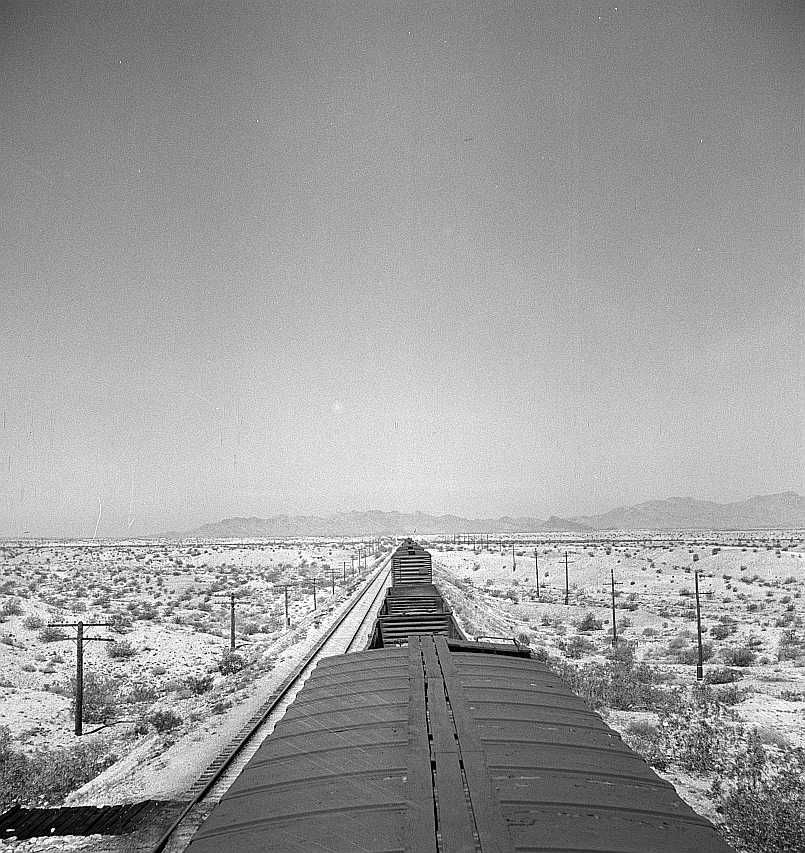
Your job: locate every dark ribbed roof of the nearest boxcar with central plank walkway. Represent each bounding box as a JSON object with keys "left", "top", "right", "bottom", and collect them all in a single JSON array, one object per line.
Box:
[{"left": 188, "top": 635, "right": 731, "bottom": 853}]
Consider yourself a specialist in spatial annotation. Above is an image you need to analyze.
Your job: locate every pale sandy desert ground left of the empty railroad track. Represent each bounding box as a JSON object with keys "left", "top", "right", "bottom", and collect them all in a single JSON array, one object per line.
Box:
[{"left": 0, "top": 541, "right": 384, "bottom": 804}]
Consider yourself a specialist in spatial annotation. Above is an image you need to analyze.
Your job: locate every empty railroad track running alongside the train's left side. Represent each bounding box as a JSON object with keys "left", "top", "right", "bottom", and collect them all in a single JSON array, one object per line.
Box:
[{"left": 150, "top": 554, "right": 391, "bottom": 853}]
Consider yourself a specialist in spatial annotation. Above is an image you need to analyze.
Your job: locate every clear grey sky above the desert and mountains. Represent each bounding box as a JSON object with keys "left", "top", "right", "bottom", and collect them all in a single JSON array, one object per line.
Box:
[{"left": 0, "top": 0, "right": 805, "bottom": 537}]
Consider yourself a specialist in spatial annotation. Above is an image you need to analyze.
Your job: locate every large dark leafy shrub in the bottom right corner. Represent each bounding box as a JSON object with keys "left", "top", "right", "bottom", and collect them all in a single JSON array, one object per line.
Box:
[{"left": 711, "top": 732, "right": 805, "bottom": 853}]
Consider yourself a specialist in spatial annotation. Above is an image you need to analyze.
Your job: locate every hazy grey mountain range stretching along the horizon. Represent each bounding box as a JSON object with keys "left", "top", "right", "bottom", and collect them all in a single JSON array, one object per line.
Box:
[{"left": 176, "top": 492, "right": 805, "bottom": 539}]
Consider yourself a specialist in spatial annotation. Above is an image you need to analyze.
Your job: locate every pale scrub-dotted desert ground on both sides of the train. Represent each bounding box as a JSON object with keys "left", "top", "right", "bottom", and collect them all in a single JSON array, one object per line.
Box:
[{"left": 0, "top": 531, "right": 805, "bottom": 851}]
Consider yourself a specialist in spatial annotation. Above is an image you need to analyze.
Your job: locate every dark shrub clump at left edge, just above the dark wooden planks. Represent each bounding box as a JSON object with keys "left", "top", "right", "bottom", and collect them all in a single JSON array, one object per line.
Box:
[{"left": 0, "top": 726, "right": 116, "bottom": 812}]
